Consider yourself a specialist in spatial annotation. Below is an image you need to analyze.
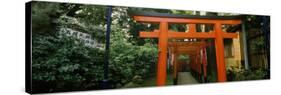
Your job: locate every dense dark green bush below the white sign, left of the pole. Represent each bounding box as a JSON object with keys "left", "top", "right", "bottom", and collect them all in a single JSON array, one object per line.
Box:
[{"left": 32, "top": 35, "right": 103, "bottom": 91}]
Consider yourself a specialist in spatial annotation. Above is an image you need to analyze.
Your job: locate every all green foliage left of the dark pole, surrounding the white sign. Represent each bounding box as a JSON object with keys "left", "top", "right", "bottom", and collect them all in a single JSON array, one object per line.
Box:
[{"left": 31, "top": 2, "right": 104, "bottom": 92}]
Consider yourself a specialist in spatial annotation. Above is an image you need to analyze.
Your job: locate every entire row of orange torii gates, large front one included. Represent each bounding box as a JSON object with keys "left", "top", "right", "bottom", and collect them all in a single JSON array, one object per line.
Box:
[{"left": 133, "top": 14, "right": 241, "bottom": 86}]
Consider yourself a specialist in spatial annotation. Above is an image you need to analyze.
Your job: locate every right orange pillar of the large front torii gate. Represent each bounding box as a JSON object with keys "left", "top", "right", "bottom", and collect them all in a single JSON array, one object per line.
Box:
[{"left": 215, "top": 23, "right": 226, "bottom": 82}]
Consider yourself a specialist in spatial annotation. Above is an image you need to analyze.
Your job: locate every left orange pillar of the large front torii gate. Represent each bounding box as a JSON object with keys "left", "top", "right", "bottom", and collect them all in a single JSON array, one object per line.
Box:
[{"left": 157, "top": 22, "right": 168, "bottom": 86}]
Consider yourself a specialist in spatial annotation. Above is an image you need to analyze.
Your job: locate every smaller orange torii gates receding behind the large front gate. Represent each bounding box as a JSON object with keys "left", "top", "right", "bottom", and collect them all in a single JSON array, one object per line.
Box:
[{"left": 168, "top": 41, "right": 211, "bottom": 84}]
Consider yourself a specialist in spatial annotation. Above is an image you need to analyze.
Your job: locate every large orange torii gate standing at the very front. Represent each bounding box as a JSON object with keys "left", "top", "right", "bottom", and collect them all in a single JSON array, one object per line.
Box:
[{"left": 133, "top": 14, "right": 241, "bottom": 86}]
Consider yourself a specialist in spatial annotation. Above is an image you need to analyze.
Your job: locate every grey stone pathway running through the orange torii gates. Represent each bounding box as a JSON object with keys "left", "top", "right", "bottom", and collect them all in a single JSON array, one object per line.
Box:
[{"left": 178, "top": 72, "right": 198, "bottom": 85}]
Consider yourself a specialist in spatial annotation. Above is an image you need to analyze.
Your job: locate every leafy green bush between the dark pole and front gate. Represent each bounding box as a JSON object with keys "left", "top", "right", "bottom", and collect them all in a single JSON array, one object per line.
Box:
[{"left": 110, "top": 27, "right": 158, "bottom": 85}]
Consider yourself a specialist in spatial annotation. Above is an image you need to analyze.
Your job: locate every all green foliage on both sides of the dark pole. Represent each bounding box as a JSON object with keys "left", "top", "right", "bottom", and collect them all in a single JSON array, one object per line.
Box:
[{"left": 32, "top": 2, "right": 158, "bottom": 92}]
